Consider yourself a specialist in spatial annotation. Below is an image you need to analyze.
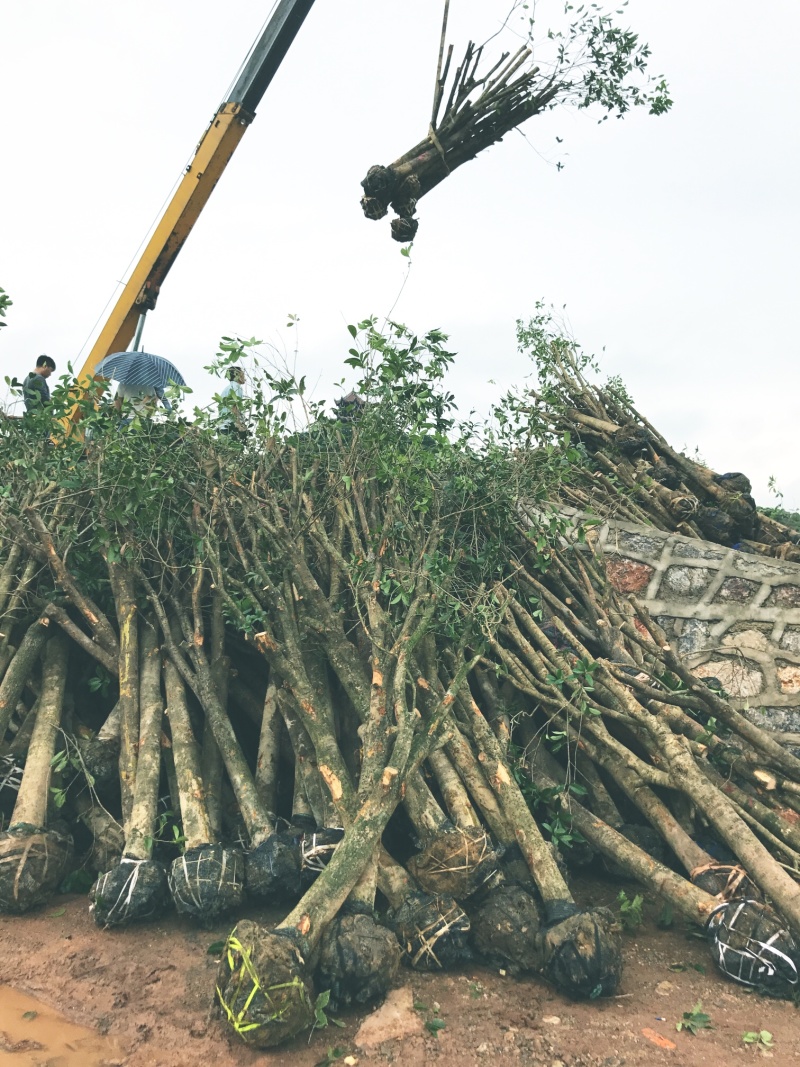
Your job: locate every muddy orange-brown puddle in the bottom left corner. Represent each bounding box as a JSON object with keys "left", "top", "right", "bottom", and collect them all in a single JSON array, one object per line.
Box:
[{"left": 0, "top": 985, "right": 125, "bottom": 1067}]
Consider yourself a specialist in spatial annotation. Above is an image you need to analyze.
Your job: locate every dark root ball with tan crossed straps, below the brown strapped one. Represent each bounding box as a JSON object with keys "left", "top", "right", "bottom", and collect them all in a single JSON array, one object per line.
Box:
[{"left": 387, "top": 891, "right": 473, "bottom": 971}]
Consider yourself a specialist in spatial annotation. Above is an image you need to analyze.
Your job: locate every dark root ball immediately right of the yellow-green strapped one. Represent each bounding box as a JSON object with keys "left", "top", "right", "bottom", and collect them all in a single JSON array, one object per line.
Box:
[{"left": 315, "top": 913, "right": 401, "bottom": 1010}]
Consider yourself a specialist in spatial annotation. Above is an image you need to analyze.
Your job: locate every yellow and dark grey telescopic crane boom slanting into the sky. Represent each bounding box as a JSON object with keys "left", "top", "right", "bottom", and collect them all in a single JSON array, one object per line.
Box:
[{"left": 78, "top": 0, "right": 314, "bottom": 381}]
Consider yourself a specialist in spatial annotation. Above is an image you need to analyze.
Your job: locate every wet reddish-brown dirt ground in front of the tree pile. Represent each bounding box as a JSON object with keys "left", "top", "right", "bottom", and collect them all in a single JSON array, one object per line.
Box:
[{"left": 0, "top": 883, "right": 800, "bottom": 1067}]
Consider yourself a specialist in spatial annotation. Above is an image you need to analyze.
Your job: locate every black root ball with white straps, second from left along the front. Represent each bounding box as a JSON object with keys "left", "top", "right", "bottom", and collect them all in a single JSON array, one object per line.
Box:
[{"left": 90, "top": 856, "right": 170, "bottom": 927}]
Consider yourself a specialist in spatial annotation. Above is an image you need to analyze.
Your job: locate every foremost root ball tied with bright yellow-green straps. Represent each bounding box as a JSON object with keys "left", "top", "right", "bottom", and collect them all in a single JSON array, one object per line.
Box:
[{"left": 217, "top": 920, "right": 315, "bottom": 1049}]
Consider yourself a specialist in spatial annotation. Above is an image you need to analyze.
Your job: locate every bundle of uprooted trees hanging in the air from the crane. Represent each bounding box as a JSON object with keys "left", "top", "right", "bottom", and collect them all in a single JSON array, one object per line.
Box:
[{"left": 362, "top": 0, "right": 672, "bottom": 241}]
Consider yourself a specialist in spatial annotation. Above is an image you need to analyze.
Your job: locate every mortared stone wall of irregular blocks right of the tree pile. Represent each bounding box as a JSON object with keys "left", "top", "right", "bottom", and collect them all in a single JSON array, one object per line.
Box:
[{"left": 589, "top": 521, "right": 800, "bottom": 732}]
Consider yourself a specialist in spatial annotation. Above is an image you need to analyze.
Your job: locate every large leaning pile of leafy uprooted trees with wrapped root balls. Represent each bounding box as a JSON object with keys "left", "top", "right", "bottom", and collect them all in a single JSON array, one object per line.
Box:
[{"left": 0, "top": 320, "right": 800, "bottom": 1047}]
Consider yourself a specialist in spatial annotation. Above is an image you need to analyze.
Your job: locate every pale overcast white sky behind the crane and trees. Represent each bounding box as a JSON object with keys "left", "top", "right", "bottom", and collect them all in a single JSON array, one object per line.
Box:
[{"left": 0, "top": 0, "right": 800, "bottom": 507}]
